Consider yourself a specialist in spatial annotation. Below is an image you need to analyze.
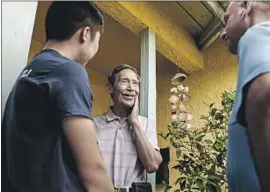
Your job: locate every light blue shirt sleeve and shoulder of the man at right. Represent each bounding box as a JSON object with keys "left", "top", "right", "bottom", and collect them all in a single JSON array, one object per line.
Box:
[{"left": 236, "top": 23, "right": 270, "bottom": 124}]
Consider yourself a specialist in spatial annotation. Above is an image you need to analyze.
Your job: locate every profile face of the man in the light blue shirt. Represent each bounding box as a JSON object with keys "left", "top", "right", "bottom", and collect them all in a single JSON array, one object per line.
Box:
[{"left": 220, "top": 3, "right": 248, "bottom": 54}]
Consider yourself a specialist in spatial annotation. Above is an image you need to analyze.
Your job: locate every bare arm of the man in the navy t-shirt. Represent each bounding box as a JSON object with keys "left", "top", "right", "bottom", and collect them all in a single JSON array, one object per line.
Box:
[{"left": 63, "top": 116, "right": 114, "bottom": 192}]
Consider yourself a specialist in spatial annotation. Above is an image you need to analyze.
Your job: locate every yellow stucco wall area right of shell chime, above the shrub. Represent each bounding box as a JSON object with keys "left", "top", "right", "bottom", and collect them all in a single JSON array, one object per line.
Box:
[{"left": 188, "top": 40, "right": 238, "bottom": 127}]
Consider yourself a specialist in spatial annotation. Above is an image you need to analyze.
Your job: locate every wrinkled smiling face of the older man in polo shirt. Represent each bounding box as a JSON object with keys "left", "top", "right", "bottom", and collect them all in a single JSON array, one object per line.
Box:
[{"left": 112, "top": 69, "right": 140, "bottom": 108}]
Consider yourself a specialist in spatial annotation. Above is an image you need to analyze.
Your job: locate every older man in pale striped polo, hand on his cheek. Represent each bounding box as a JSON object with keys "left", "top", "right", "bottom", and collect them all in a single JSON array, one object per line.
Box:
[{"left": 94, "top": 65, "right": 162, "bottom": 188}]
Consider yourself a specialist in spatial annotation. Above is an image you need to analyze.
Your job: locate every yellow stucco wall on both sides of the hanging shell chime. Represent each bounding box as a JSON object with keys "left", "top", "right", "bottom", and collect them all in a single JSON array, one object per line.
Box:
[{"left": 157, "top": 40, "right": 237, "bottom": 191}]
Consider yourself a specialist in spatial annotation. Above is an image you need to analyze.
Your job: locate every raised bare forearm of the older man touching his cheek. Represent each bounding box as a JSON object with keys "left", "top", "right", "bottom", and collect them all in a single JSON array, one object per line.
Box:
[{"left": 132, "top": 123, "right": 162, "bottom": 173}]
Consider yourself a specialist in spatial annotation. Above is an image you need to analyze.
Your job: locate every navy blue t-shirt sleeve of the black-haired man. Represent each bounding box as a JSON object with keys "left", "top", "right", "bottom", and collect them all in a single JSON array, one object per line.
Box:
[{"left": 49, "top": 62, "right": 92, "bottom": 119}]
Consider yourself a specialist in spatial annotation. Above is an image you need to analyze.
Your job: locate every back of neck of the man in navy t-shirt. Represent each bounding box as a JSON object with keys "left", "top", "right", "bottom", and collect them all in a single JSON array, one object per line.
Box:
[{"left": 43, "top": 40, "right": 83, "bottom": 65}]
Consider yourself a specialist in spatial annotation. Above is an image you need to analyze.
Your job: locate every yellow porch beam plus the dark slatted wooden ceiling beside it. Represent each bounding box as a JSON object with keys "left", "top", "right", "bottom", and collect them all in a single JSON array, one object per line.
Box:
[{"left": 95, "top": 1, "right": 228, "bottom": 74}]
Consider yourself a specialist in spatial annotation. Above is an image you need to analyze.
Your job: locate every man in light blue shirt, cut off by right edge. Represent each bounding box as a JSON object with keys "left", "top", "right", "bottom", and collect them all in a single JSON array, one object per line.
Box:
[{"left": 221, "top": 1, "right": 270, "bottom": 192}]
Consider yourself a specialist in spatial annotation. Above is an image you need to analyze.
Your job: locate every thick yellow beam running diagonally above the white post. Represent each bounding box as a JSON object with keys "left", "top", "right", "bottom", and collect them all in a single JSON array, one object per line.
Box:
[{"left": 95, "top": 1, "right": 204, "bottom": 74}]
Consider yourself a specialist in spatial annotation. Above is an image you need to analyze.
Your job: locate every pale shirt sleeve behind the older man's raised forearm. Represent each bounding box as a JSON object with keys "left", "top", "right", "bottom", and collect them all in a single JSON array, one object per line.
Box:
[{"left": 145, "top": 119, "right": 160, "bottom": 151}]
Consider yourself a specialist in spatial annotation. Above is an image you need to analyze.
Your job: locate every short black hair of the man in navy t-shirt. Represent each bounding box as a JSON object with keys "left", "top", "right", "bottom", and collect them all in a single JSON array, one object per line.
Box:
[{"left": 45, "top": 1, "right": 104, "bottom": 41}]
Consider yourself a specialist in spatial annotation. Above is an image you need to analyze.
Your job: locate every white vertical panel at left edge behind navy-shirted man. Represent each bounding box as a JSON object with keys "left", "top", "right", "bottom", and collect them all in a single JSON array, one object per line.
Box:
[{"left": 2, "top": 1, "right": 38, "bottom": 114}]
